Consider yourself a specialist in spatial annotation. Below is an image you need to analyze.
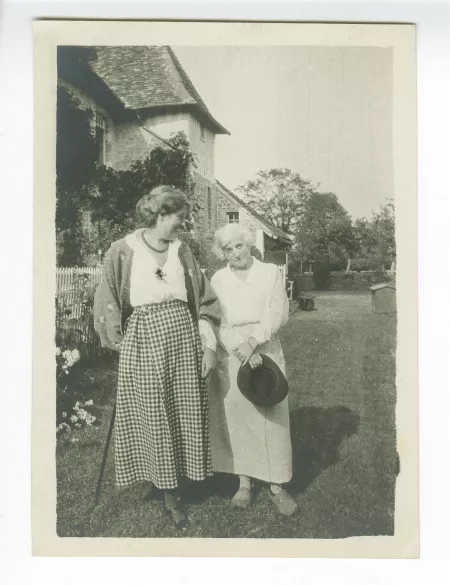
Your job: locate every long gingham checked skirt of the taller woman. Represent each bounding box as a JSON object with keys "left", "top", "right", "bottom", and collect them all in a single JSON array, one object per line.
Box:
[{"left": 115, "top": 300, "right": 212, "bottom": 489}]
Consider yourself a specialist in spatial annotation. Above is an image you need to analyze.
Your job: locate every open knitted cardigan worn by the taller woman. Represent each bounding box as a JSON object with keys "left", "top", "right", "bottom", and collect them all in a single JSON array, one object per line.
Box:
[{"left": 94, "top": 239, "right": 220, "bottom": 350}]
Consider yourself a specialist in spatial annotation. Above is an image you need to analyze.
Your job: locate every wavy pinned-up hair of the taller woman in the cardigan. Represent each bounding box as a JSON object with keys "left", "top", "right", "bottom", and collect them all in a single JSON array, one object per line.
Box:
[{"left": 136, "top": 185, "right": 190, "bottom": 227}]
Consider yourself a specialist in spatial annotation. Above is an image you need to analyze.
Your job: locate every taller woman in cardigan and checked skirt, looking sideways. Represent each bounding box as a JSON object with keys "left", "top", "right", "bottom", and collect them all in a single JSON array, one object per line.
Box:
[{"left": 94, "top": 186, "right": 220, "bottom": 529}]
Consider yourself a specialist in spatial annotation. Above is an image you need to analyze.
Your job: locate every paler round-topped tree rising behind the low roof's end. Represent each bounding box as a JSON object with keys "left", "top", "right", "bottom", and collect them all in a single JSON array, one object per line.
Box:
[{"left": 236, "top": 169, "right": 314, "bottom": 234}]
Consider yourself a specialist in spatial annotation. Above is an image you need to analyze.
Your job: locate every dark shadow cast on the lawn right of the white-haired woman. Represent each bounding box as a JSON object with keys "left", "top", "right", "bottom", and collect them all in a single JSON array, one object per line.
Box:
[{"left": 289, "top": 406, "right": 359, "bottom": 493}]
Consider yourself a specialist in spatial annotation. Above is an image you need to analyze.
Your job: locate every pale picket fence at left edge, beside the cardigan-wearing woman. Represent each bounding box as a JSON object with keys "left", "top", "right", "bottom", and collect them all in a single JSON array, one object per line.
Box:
[{"left": 56, "top": 266, "right": 102, "bottom": 358}]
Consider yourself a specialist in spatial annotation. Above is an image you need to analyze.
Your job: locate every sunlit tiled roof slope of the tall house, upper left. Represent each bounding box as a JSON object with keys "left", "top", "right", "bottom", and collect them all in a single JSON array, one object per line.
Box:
[{"left": 90, "top": 46, "right": 229, "bottom": 134}]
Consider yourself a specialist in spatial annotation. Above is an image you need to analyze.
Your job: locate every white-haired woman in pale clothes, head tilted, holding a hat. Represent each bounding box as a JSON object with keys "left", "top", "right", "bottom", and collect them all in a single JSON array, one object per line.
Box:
[{"left": 210, "top": 224, "right": 297, "bottom": 516}]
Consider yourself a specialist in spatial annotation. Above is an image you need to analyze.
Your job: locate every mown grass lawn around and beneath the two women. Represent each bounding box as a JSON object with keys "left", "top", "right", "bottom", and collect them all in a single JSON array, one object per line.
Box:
[{"left": 56, "top": 293, "right": 398, "bottom": 538}]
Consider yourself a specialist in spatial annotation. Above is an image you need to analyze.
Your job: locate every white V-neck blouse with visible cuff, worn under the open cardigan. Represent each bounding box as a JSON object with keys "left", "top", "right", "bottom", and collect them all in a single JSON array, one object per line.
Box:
[{"left": 125, "top": 229, "right": 217, "bottom": 351}]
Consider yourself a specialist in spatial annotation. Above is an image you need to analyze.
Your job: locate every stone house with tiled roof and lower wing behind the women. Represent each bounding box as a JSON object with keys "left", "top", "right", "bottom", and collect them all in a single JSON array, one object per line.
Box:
[{"left": 58, "top": 46, "right": 291, "bottom": 265}]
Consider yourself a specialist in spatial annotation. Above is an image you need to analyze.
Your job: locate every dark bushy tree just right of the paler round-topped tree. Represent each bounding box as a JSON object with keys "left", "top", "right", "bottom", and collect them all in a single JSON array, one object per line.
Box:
[{"left": 292, "top": 191, "right": 355, "bottom": 268}]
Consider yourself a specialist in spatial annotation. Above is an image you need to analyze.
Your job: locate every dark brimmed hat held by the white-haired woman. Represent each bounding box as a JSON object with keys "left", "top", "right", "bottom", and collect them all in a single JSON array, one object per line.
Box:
[{"left": 237, "top": 354, "right": 288, "bottom": 406}]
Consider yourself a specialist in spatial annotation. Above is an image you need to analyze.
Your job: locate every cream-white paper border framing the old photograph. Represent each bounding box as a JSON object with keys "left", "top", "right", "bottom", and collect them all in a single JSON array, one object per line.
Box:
[{"left": 32, "top": 21, "right": 419, "bottom": 558}]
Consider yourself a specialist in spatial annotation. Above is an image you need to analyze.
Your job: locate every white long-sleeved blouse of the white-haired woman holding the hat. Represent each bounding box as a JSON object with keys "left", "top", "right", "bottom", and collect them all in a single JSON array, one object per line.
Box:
[{"left": 211, "top": 258, "right": 289, "bottom": 352}]
